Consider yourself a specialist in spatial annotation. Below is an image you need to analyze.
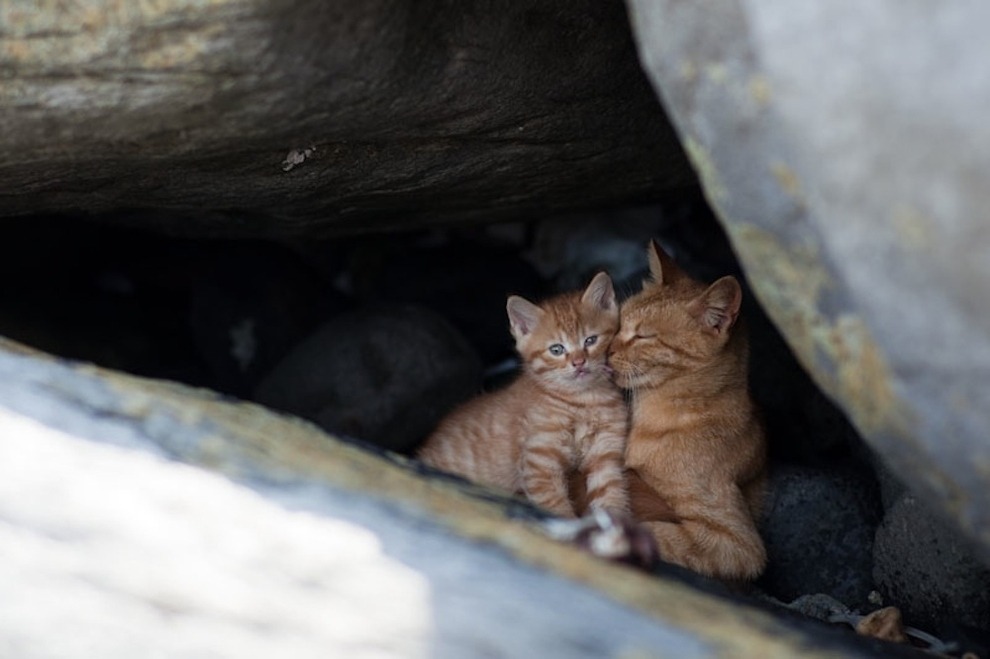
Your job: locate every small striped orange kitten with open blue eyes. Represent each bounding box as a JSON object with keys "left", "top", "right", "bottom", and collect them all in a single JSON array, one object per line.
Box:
[{"left": 417, "top": 272, "right": 629, "bottom": 517}]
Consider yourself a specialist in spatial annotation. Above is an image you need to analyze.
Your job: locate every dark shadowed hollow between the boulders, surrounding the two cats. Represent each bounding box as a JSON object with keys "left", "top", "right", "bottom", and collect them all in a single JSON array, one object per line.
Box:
[{"left": 0, "top": 190, "right": 990, "bottom": 654}]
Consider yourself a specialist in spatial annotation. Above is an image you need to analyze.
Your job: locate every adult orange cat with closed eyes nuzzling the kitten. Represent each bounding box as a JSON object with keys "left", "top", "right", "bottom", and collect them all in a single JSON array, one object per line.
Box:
[{"left": 609, "top": 243, "right": 766, "bottom": 580}]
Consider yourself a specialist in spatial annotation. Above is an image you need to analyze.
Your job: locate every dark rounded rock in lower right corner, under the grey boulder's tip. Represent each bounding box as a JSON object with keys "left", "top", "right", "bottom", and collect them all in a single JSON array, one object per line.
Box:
[{"left": 873, "top": 491, "right": 990, "bottom": 631}]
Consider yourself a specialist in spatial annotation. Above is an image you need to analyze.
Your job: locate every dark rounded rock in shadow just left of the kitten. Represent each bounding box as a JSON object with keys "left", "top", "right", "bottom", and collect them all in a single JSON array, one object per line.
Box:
[{"left": 254, "top": 307, "right": 481, "bottom": 452}]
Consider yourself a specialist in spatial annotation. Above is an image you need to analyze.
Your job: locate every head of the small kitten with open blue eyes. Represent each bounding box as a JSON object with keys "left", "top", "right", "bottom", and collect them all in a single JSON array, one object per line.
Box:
[{"left": 506, "top": 272, "right": 619, "bottom": 391}]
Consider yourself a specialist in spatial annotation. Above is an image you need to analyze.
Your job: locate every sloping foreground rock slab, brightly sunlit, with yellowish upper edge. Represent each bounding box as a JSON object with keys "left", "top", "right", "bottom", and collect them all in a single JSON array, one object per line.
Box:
[{"left": 0, "top": 343, "right": 916, "bottom": 659}]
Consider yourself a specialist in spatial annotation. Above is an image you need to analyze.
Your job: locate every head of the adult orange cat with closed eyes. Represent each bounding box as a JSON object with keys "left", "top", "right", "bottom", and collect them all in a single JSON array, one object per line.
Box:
[{"left": 609, "top": 242, "right": 742, "bottom": 389}]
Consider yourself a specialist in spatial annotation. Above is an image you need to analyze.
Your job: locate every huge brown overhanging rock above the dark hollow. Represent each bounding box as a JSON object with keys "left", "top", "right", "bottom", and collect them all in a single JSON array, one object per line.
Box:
[{"left": 0, "top": 0, "right": 693, "bottom": 232}]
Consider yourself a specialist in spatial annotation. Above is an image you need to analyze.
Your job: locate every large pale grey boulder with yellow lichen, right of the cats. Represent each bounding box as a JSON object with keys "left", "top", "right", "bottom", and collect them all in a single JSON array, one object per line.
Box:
[{"left": 628, "top": 0, "right": 990, "bottom": 560}]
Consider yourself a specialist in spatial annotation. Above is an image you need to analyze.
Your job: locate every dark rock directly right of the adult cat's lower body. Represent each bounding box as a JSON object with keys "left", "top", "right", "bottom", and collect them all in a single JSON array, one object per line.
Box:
[{"left": 760, "top": 464, "right": 883, "bottom": 609}]
